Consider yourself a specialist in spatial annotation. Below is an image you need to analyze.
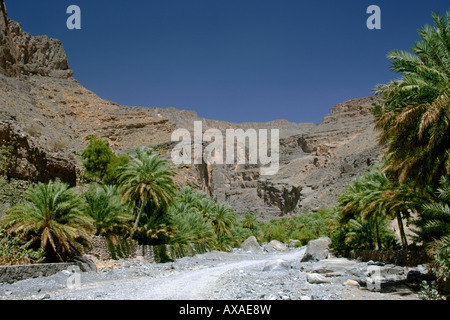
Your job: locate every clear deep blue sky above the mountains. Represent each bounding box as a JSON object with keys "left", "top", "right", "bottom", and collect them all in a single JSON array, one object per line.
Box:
[{"left": 5, "top": 0, "right": 450, "bottom": 123}]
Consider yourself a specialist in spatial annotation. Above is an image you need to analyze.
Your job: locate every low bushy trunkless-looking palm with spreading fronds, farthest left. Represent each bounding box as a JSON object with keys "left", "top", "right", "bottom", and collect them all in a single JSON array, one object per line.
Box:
[{"left": 2, "top": 181, "right": 93, "bottom": 262}]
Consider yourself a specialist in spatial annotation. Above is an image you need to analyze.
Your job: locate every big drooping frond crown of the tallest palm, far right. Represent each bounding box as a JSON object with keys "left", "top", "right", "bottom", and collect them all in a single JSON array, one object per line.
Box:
[{"left": 373, "top": 11, "right": 450, "bottom": 188}]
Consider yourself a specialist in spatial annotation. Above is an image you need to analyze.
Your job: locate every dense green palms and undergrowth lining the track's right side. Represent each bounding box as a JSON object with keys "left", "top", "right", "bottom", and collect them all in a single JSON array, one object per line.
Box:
[{"left": 312, "top": 11, "right": 450, "bottom": 298}]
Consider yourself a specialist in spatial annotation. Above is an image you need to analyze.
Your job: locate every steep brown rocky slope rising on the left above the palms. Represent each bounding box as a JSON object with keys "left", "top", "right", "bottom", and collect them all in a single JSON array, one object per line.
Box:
[{"left": 0, "top": 1, "right": 174, "bottom": 185}]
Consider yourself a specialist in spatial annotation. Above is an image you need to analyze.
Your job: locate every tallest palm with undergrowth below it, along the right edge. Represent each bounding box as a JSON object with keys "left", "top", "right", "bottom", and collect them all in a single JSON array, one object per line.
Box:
[{"left": 360, "top": 11, "right": 450, "bottom": 296}]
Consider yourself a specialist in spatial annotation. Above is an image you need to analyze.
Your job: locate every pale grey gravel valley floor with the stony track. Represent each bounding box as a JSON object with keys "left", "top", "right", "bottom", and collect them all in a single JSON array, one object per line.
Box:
[{"left": 0, "top": 247, "right": 426, "bottom": 300}]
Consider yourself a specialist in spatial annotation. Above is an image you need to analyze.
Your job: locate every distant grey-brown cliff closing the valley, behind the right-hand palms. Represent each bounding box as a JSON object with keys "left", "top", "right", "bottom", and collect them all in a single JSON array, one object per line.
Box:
[{"left": 164, "top": 97, "right": 382, "bottom": 219}]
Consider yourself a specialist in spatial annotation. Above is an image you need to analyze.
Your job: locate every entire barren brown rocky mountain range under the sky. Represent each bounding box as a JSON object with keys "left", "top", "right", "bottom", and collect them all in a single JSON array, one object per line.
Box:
[{"left": 0, "top": 1, "right": 381, "bottom": 219}]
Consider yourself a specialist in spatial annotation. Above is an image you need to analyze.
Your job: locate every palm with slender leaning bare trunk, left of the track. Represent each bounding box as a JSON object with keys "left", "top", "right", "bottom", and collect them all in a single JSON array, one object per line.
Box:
[{"left": 117, "top": 148, "right": 177, "bottom": 234}]
